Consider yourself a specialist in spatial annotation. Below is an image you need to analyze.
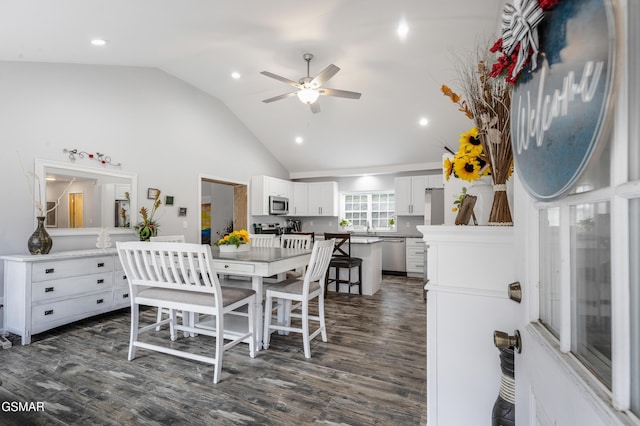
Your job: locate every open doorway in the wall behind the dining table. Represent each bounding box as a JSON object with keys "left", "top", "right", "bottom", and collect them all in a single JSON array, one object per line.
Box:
[{"left": 200, "top": 177, "right": 248, "bottom": 244}]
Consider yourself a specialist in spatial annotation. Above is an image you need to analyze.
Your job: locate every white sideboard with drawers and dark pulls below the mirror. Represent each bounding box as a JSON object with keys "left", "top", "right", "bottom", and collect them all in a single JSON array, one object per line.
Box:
[{"left": 0, "top": 249, "right": 130, "bottom": 345}]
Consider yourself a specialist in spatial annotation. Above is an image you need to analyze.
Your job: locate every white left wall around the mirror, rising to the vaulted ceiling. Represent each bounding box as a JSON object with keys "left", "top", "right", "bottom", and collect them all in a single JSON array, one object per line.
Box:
[{"left": 0, "top": 62, "right": 288, "bottom": 330}]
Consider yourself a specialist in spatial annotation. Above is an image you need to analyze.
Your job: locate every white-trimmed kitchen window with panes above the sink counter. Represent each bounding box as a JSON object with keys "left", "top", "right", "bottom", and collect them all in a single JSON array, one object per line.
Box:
[{"left": 340, "top": 191, "right": 396, "bottom": 231}]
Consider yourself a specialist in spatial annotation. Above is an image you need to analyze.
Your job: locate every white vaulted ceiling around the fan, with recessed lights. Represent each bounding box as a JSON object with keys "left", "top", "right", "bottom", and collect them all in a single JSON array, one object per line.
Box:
[{"left": 0, "top": 0, "right": 503, "bottom": 177}]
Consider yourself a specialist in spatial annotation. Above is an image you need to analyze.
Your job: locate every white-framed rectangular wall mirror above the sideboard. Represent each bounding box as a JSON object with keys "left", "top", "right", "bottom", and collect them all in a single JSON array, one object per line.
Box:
[{"left": 35, "top": 159, "right": 138, "bottom": 236}]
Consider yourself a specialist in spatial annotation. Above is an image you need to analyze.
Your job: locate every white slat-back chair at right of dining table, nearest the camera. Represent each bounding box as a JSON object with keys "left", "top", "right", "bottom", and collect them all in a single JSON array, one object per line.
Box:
[{"left": 263, "top": 240, "right": 335, "bottom": 358}]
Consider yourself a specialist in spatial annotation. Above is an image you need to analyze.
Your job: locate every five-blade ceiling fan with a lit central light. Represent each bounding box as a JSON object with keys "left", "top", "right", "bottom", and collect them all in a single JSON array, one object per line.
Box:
[{"left": 260, "top": 53, "right": 361, "bottom": 113}]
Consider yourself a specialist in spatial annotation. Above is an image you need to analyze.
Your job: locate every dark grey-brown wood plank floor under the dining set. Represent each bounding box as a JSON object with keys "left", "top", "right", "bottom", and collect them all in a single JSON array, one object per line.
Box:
[{"left": 0, "top": 276, "right": 426, "bottom": 426}]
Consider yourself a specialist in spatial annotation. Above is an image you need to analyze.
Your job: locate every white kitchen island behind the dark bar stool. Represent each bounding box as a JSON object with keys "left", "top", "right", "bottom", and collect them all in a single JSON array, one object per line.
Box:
[{"left": 328, "top": 237, "right": 383, "bottom": 296}]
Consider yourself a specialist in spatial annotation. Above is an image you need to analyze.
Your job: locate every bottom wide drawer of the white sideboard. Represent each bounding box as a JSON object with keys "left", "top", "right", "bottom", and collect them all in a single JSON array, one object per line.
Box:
[{"left": 31, "top": 291, "right": 113, "bottom": 324}]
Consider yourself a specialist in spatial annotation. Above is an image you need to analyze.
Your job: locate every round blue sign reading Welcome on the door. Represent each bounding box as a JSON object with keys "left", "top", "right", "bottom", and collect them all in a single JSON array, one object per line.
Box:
[{"left": 511, "top": 0, "right": 615, "bottom": 201}]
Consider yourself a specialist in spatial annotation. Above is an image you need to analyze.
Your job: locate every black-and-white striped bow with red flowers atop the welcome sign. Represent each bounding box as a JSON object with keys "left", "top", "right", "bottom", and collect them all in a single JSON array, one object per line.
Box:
[{"left": 489, "top": 0, "right": 560, "bottom": 86}]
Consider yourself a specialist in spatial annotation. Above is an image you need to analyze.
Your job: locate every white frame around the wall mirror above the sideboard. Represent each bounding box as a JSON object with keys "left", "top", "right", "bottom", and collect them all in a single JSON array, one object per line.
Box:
[{"left": 34, "top": 158, "right": 138, "bottom": 236}]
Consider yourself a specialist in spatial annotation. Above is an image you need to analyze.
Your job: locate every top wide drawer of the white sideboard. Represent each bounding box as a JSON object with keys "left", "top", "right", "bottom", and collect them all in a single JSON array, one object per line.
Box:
[{"left": 31, "top": 256, "right": 113, "bottom": 281}]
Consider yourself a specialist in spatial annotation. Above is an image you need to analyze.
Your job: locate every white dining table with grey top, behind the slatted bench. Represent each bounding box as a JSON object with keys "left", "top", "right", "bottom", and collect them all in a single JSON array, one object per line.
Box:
[{"left": 211, "top": 246, "right": 311, "bottom": 350}]
